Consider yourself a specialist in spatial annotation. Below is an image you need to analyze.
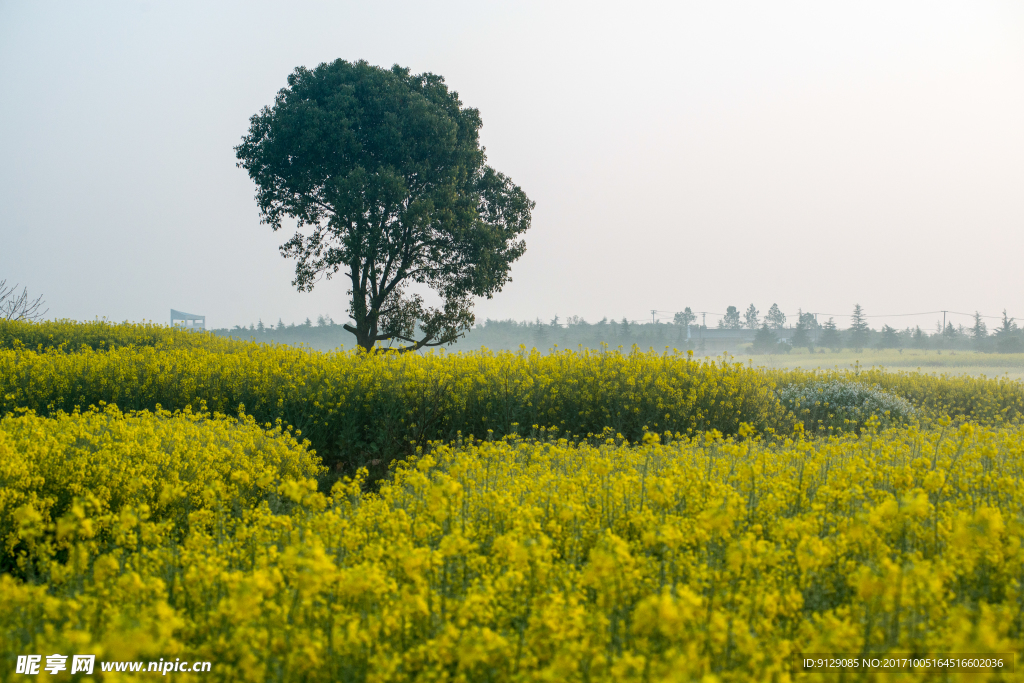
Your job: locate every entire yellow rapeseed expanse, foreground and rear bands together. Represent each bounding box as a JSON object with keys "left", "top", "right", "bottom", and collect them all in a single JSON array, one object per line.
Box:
[{"left": 0, "top": 329, "right": 1024, "bottom": 683}]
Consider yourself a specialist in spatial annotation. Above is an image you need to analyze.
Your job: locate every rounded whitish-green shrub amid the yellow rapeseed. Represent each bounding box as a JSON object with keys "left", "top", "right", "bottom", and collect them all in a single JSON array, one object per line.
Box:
[{"left": 779, "top": 379, "right": 914, "bottom": 431}]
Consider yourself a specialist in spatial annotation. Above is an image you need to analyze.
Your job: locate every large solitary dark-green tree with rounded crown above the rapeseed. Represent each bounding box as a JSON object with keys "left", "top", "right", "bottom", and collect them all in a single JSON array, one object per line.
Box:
[{"left": 236, "top": 59, "right": 534, "bottom": 351}]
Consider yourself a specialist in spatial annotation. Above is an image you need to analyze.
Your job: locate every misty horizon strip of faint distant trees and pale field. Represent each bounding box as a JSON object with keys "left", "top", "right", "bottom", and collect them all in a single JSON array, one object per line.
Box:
[{"left": 213, "top": 309, "right": 1024, "bottom": 380}]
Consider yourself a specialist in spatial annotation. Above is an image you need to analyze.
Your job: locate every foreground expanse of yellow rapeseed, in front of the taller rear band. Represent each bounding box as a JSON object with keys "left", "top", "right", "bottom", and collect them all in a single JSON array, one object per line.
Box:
[{"left": 0, "top": 409, "right": 1024, "bottom": 681}]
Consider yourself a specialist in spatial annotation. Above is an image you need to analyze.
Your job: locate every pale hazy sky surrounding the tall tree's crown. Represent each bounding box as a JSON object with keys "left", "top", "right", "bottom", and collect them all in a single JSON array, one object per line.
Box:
[{"left": 0, "top": 0, "right": 1024, "bottom": 329}]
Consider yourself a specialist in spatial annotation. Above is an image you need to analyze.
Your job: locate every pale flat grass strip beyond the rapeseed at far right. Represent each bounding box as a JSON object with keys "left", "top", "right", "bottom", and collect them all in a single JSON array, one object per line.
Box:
[{"left": 734, "top": 349, "right": 1024, "bottom": 380}]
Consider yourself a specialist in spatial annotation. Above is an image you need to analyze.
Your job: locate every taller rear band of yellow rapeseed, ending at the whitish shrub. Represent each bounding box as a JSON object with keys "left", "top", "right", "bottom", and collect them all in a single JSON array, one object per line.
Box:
[{"left": 0, "top": 342, "right": 785, "bottom": 474}]
